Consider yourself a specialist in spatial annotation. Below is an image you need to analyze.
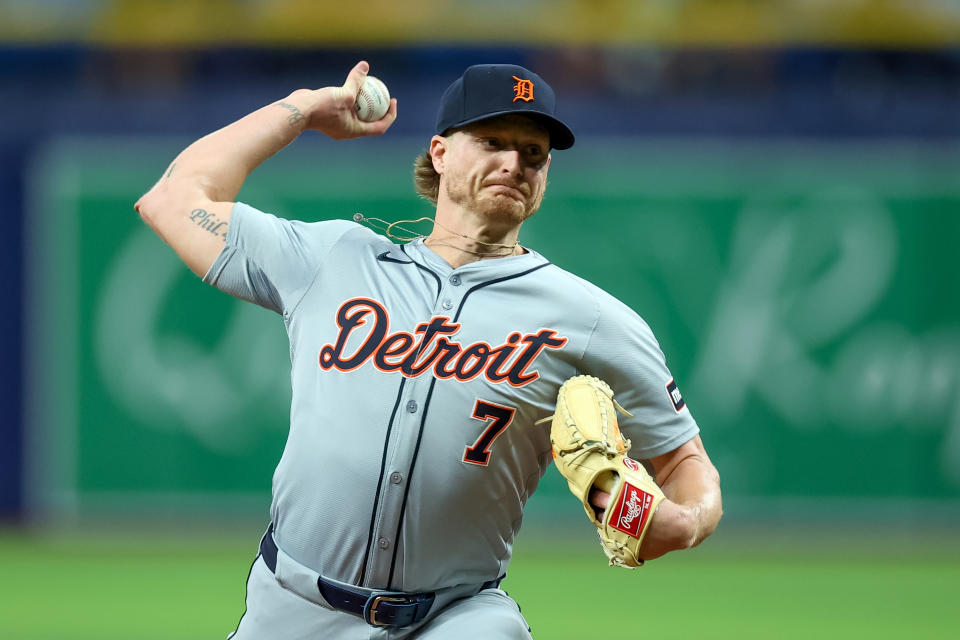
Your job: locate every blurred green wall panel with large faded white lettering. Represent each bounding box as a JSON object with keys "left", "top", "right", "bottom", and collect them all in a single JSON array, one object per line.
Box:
[{"left": 25, "top": 136, "right": 960, "bottom": 518}]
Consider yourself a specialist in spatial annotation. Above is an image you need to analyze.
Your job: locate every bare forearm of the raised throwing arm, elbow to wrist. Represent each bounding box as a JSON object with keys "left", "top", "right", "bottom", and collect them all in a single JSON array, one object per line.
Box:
[{"left": 155, "top": 92, "right": 306, "bottom": 202}]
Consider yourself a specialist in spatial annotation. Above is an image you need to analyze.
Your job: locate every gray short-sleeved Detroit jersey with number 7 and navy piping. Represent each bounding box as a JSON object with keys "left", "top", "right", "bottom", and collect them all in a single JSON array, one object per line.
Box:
[{"left": 204, "top": 203, "right": 698, "bottom": 592}]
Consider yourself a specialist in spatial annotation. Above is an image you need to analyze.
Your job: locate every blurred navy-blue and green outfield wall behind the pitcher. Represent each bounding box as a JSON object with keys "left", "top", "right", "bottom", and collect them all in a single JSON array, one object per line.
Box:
[{"left": 0, "top": 42, "right": 960, "bottom": 521}]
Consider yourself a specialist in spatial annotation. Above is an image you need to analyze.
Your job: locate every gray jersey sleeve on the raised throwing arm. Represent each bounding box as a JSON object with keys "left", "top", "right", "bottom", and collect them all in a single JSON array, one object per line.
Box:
[{"left": 203, "top": 202, "right": 356, "bottom": 314}]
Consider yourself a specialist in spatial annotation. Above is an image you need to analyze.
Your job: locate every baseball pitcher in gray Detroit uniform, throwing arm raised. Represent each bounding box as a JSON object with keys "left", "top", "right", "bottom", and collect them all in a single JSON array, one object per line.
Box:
[{"left": 136, "top": 62, "right": 721, "bottom": 640}]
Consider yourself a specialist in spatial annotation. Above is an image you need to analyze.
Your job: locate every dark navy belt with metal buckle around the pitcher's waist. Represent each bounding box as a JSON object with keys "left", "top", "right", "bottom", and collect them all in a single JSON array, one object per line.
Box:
[{"left": 260, "top": 525, "right": 503, "bottom": 627}]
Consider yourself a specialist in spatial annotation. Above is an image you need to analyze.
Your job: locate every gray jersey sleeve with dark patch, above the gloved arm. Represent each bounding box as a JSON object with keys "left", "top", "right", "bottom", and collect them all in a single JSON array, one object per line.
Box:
[{"left": 584, "top": 296, "right": 700, "bottom": 459}]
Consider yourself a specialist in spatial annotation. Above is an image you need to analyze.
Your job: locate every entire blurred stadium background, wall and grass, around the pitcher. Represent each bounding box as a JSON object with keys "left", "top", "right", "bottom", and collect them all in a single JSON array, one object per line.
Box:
[{"left": 0, "top": 0, "right": 960, "bottom": 640}]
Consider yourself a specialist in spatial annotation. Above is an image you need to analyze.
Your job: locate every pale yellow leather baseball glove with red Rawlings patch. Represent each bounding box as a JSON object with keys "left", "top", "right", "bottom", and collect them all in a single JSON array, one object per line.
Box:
[{"left": 547, "top": 376, "right": 664, "bottom": 569}]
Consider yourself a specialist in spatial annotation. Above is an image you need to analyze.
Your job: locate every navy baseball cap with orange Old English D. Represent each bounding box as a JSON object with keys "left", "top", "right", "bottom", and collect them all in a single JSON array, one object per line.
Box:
[{"left": 437, "top": 64, "right": 574, "bottom": 149}]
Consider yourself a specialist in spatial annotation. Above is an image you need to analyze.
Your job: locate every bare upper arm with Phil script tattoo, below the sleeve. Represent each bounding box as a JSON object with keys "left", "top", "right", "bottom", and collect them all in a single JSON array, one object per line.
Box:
[{"left": 134, "top": 188, "right": 234, "bottom": 277}]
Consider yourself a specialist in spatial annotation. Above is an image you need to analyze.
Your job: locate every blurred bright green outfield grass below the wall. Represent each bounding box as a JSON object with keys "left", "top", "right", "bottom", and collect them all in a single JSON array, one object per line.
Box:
[{"left": 0, "top": 531, "right": 960, "bottom": 640}]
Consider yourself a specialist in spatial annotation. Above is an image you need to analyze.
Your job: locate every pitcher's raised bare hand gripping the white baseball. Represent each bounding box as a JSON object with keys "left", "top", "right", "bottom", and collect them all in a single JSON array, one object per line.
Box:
[{"left": 286, "top": 60, "right": 397, "bottom": 140}]
